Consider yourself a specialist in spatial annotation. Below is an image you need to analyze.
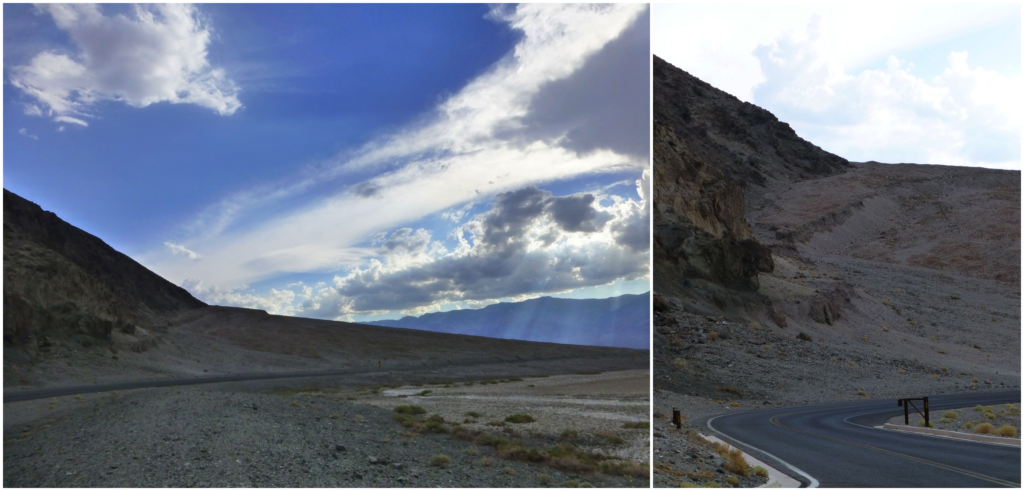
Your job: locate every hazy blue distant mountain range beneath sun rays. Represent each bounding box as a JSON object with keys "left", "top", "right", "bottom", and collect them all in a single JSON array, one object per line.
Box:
[{"left": 364, "top": 292, "right": 650, "bottom": 350}]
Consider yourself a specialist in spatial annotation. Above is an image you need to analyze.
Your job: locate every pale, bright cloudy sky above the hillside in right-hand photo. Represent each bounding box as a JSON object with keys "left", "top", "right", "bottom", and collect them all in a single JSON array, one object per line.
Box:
[{"left": 651, "top": 2, "right": 1024, "bottom": 170}]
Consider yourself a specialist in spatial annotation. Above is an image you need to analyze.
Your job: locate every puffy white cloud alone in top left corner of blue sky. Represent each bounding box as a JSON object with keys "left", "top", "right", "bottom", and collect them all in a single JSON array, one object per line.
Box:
[{"left": 9, "top": 4, "right": 242, "bottom": 126}]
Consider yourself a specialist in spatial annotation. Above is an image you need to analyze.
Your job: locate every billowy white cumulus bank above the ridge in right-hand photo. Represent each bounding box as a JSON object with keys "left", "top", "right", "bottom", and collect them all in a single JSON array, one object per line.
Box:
[{"left": 755, "top": 17, "right": 1022, "bottom": 168}]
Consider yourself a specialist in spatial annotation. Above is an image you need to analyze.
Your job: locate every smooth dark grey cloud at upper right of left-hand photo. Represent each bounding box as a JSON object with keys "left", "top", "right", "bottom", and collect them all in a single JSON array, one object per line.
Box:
[{"left": 515, "top": 9, "right": 650, "bottom": 159}]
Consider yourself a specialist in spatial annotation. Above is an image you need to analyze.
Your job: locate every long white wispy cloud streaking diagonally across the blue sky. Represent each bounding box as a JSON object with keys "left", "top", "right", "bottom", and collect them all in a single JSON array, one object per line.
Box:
[{"left": 141, "top": 4, "right": 649, "bottom": 289}]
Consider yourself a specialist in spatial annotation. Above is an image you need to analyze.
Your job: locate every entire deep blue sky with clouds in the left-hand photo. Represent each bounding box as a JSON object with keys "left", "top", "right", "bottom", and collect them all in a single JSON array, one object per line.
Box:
[{"left": 3, "top": 4, "right": 650, "bottom": 320}]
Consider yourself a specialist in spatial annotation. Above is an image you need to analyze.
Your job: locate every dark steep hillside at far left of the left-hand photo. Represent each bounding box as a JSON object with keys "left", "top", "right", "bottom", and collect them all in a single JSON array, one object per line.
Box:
[{"left": 3, "top": 190, "right": 205, "bottom": 351}]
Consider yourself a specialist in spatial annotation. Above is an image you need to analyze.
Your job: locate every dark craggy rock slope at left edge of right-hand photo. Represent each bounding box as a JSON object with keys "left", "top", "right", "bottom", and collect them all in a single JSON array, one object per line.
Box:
[{"left": 654, "top": 56, "right": 850, "bottom": 313}]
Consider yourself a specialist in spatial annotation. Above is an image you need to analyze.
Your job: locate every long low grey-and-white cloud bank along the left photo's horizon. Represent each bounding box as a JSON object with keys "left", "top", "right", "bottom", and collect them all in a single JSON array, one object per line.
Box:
[{"left": 183, "top": 182, "right": 650, "bottom": 320}]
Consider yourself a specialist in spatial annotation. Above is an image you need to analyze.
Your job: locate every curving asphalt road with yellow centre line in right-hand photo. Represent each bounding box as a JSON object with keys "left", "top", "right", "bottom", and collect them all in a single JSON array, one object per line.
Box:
[{"left": 708, "top": 391, "right": 1021, "bottom": 488}]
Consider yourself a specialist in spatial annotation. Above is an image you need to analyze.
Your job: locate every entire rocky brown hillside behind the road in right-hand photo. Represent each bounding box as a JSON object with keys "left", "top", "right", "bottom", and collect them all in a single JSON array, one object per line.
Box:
[{"left": 653, "top": 53, "right": 1021, "bottom": 414}]
